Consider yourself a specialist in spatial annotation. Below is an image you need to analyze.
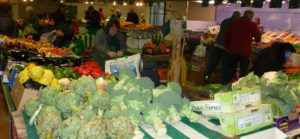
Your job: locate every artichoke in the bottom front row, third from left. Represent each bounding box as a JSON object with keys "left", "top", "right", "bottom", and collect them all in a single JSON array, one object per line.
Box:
[{"left": 77, "top": 116, "right": 107, "bottom": 139}]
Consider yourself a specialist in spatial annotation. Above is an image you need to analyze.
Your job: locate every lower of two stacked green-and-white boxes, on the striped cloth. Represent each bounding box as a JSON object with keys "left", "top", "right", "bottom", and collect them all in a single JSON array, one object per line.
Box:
[{"left": 220, "top": 104, "right": 273, "bottom": 135}]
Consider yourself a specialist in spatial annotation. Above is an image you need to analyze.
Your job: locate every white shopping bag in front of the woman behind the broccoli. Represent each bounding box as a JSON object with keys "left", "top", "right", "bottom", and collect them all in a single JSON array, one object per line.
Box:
[{"left": 105, "top": 54, "right": 141, "bottom": 78}]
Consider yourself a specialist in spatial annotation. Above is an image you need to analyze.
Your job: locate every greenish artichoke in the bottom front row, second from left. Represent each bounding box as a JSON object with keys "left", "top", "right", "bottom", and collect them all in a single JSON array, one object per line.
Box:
[{"left": 57, "top": 116, "right": 85, "bottom": 139}]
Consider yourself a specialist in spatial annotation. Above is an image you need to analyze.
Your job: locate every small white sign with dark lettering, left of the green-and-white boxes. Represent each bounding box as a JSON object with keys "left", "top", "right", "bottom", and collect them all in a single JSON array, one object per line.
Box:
[{"left": 190, "top": 101, "right": 222, "bottom": 112}]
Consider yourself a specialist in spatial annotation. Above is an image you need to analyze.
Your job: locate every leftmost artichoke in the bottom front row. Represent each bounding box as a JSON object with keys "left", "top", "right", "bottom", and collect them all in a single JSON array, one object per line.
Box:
[{"left": 35, "top": 112, "right": 62, "bottom": 139}]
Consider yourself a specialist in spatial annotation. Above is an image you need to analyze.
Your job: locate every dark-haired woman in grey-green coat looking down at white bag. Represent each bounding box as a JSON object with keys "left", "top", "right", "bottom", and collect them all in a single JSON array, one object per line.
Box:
[{"left": 93, "top": 19, "right": 127, "bottom": 71}]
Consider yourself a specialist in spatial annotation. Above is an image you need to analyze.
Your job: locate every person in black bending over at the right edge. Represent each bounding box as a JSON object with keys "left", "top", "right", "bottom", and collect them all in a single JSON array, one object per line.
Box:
[{"left": 252, "top": 42, "right": 296, "bottom": 76}]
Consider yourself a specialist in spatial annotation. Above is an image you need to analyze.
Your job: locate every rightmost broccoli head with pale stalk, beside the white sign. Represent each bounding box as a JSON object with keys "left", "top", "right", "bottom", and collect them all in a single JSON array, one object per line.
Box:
[{"left": 175, "top": 98, "right": 200, "bottom": 122}]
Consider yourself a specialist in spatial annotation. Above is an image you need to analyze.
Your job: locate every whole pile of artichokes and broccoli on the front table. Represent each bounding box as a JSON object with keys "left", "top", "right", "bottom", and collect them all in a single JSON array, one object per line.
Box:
[{"left": 25, "top": 71, "right": 199, "bottom": 139}]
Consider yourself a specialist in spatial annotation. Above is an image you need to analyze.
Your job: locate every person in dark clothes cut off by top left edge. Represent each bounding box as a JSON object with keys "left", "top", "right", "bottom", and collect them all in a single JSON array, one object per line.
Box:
[{"left": 0, "top": 2, "right": 18, "bottom": 38}]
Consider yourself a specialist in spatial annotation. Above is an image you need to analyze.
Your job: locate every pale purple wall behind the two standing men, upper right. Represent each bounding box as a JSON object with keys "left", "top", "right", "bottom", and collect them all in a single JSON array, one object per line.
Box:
[{"left": 216, "top": 3, "right": 300, "bottom": 34}]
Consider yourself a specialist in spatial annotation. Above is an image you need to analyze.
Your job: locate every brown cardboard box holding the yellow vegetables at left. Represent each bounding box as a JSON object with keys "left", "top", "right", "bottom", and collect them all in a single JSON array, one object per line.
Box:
[{"left": 10, "top": 77, "right": 38, "bottom": 111}]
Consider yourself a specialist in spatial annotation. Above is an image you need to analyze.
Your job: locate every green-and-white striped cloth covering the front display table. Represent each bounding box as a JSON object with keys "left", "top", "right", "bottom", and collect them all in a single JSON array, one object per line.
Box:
[{"left": 3, "top": 81, "right": 288, "bottom": 139}]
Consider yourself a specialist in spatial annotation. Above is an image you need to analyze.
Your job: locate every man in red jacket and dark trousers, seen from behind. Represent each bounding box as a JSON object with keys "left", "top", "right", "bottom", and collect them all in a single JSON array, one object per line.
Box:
[{"left": 224, "top": 10, "right": 262, "bottom": 77}]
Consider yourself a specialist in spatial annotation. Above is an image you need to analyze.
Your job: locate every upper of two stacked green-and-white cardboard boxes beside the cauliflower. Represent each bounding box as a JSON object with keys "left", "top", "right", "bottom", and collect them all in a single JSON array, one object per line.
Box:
[{"left": 215, "top": 86, "right": 261, "bottom": 112}]
